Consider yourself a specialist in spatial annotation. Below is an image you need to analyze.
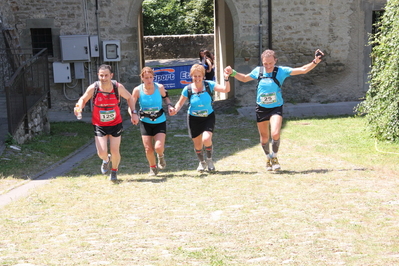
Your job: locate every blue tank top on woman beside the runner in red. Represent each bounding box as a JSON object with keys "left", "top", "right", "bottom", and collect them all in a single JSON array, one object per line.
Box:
[{"left": 139, "top": 82, "right": 166, "bottom": 124}]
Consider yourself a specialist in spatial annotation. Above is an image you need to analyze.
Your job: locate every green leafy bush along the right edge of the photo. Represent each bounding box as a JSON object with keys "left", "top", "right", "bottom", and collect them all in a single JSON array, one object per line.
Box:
[{"left": 357, "top": 0, "right": 399, "bottom": 141}]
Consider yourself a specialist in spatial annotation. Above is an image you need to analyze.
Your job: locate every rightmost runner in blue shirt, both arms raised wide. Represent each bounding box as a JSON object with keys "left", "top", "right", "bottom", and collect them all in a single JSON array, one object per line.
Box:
[{"left": 224, "top": 50, "right": 324, "bottom": 171}]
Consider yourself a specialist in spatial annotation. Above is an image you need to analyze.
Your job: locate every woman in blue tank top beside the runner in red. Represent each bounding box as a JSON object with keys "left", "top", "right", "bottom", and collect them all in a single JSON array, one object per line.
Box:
[{"left": 129, "top": 67, "right": 174, "bottom": 176}]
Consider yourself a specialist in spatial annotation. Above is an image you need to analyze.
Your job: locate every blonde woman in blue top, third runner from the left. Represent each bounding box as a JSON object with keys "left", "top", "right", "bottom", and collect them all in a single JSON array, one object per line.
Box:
[{"left": 172, "top": 64, "right": 230, "bottom": 172}]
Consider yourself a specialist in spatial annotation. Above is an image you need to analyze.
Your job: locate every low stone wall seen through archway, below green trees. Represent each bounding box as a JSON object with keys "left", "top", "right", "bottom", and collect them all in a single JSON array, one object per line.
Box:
[{"left": 144, "top": 34, "right": 214, "bottom": 60}]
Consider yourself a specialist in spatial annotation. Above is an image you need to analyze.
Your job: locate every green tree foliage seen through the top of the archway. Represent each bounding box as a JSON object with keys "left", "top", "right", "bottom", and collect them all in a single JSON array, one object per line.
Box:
[{"left": 143, "top": 0, "right": 213, "bottom": 36}]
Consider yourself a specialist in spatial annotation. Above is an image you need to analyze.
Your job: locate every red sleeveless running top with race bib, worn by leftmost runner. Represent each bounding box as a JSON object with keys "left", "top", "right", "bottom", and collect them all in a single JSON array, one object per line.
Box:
[{"left": 91, "top": 86, "right": 122, "bottom": 127}]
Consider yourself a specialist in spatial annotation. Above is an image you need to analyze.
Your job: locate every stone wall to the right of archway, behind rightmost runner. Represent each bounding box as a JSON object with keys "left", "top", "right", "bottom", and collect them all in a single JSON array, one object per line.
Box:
[{"left": 228, "top": 0, "right": 386, "bottom": 105}]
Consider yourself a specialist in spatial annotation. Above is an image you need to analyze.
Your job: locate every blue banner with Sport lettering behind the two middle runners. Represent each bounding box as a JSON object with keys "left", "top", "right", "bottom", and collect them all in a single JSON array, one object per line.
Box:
[{"left": 153, "top": 65, "right": 192, "bottom": 90}]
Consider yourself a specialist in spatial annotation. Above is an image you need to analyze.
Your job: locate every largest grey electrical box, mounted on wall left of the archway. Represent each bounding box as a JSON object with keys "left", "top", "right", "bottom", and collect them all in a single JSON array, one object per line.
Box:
[{"left": 60, "top": 35, "right": 90, "bottom": 62}]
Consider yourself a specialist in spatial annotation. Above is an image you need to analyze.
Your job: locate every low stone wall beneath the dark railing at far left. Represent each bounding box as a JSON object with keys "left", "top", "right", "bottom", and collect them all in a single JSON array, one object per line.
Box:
[{"left": 13, "top": 99, "right": 50, "bottom": 144}]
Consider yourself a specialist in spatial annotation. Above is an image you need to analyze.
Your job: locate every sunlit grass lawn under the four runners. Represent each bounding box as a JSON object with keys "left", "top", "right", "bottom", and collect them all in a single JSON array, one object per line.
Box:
[{"left": 0, "top": 111, "right": 399, "bottom": 265}]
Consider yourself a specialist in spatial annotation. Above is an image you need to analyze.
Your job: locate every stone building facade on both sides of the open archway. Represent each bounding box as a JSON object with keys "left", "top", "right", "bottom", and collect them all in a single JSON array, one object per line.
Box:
[{"left": 0, "top": 0, "right": 386, "bottom": 110}]
